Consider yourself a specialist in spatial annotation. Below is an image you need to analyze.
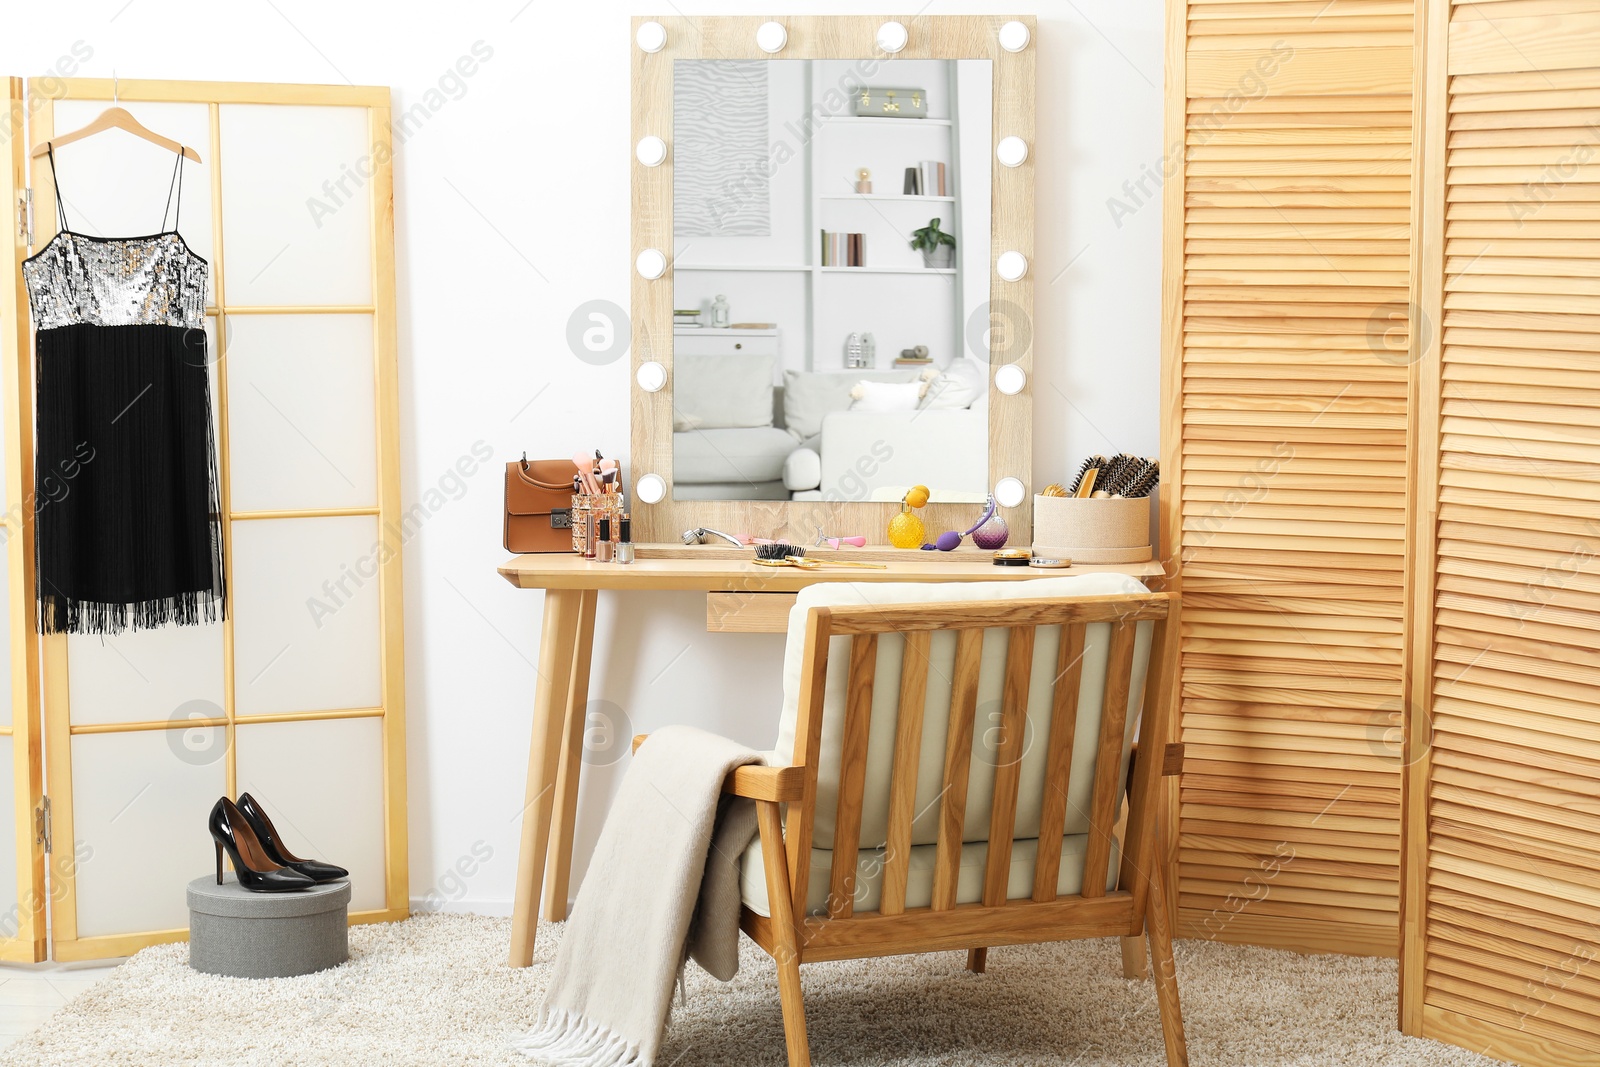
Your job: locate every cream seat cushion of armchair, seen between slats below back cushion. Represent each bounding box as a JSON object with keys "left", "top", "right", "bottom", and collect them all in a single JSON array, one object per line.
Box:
[{"left": 739, "top": 833, "right": 1122, "bottom": 917}]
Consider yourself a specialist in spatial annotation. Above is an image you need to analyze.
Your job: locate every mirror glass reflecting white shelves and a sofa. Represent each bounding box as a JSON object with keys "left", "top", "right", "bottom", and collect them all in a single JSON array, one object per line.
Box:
[{"left": 670, "top": 59, "right": 992, "bottom": 501}]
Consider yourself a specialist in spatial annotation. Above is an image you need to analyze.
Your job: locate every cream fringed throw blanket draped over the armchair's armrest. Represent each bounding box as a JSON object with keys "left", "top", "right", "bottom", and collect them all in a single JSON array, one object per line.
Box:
[{"left": 515, "top": 726, "right": 762, "bottom": 1067}]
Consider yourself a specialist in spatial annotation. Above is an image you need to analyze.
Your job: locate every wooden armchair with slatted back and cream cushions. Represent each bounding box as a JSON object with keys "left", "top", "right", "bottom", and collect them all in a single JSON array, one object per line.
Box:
[{"left": 643, "top": 576, "right": 1187, "bottom": 1067}]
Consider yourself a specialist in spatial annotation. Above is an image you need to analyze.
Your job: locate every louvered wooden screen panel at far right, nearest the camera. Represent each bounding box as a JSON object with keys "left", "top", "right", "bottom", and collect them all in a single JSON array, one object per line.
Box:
[{"left": 1402, "top": 0, "right": 1600, "bottom": 1067}]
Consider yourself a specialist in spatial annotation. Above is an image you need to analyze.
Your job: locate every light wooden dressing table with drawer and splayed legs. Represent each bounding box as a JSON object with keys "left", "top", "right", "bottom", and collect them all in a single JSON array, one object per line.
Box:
[{"left": 499, "top": 544, "right": 1163, "bottom": 966}]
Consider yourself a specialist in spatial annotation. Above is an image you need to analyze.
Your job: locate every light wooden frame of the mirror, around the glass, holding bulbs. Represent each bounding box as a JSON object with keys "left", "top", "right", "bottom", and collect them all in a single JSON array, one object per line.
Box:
[{"left": 627, "top": 14, "right": 1038, "bottom": 544}]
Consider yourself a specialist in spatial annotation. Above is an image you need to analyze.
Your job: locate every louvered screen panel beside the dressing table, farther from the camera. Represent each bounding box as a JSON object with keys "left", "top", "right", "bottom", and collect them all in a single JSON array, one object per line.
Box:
[{"left": 1166, "top": 0, "right": 1413, "bottom": 955}]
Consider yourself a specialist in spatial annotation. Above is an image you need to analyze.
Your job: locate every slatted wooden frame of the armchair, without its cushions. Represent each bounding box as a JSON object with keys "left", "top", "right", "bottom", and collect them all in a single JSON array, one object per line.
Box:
[{"left": 744, "top": 593, "right": 1186, "bottom": 1064}]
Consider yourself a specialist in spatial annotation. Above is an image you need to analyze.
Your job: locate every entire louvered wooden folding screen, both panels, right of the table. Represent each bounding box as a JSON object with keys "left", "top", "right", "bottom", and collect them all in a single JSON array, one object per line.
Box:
[{"left": 1163, "top": 0, "right": 1600, "bottom": 1067}]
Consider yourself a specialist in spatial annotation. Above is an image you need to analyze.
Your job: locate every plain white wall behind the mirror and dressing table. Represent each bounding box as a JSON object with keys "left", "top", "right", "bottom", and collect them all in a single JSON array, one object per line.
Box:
[{"left": 0, "top": 0, "right": 1163, "bottom": 912}]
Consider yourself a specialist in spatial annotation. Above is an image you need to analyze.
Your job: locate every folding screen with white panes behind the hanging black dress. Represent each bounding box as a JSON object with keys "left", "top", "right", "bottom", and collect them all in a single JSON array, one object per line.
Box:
[{"left": 0, "top": 78, "right": 412, "bottom": 960}]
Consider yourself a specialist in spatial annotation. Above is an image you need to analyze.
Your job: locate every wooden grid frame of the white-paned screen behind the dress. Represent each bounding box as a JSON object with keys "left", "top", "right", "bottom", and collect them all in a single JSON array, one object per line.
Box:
[{"left": 20, "top": 78, "right": 411, "bottom": 960}]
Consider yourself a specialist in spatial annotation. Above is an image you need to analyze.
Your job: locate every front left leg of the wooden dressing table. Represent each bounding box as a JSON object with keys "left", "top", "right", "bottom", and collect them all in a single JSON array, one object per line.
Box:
[{"left": 510, "top": 589, "right": 584, "bottom": 966}]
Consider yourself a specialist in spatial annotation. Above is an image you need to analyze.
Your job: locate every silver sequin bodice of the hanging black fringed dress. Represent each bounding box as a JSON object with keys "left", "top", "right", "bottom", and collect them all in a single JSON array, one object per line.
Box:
[{"left": 22, "top": 230, "right": 208, "bottom": 330}]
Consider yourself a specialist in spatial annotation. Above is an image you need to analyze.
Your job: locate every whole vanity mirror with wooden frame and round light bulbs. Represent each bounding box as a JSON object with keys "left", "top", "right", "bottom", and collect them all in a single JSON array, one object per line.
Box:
[{"left": 632, "top": 16, "right": 1034, "bottom": 544}]
